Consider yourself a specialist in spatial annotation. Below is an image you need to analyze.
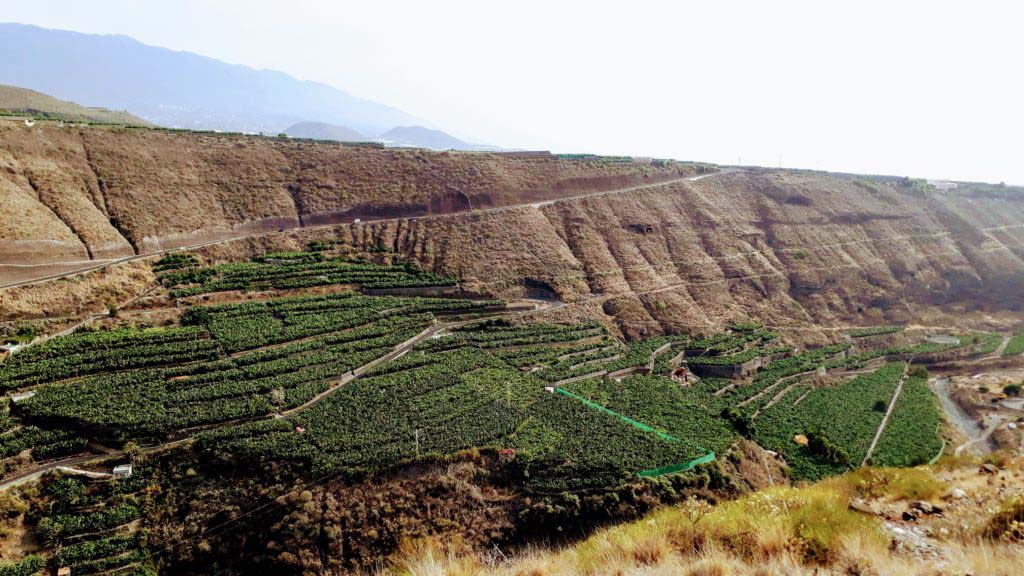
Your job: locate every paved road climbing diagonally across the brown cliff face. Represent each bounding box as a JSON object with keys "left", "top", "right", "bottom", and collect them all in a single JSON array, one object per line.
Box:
[{"left": 0, "top": 168, "right": 737, "bottom": 289}]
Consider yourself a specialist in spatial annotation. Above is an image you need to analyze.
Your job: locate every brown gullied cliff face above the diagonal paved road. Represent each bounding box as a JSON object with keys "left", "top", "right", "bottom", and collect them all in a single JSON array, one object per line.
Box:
[{"left": 0, "top": 122, "right": 695, "bottom": 265}]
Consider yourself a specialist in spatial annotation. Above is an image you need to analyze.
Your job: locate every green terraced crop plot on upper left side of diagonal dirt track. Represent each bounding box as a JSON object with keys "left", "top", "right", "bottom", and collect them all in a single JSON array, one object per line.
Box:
[{"left": 9, "top": 293, "right": 492, "bottom": 442}]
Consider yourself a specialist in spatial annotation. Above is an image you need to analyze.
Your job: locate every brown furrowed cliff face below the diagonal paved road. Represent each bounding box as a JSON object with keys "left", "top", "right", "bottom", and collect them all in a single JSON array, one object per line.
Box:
[{"left": 188, "top": 171, "right": 1024, "bottom": 337}]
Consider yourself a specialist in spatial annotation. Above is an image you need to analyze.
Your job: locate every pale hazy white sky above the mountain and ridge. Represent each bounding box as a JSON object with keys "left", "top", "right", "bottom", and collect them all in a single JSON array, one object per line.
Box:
[{"left": 8, "top": 0, "right": 1024, "bottom": 184}]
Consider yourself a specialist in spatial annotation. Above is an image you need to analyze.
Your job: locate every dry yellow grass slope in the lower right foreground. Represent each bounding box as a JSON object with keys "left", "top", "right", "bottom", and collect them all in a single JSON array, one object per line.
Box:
[{"left": 380, "top": 459, "right": 1024, "bottom": 576}]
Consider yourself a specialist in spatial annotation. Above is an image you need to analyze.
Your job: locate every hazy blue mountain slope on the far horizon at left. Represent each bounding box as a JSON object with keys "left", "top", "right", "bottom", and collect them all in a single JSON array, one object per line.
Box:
[{"left": 0, "top": 24, "right": 422, "bottom": 133}]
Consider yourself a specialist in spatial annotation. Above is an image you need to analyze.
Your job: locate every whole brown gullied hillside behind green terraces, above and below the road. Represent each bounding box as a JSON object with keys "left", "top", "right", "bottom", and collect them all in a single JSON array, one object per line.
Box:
[{"left": 6, "top": 125, "right": 1024, "bottom": 337}]
